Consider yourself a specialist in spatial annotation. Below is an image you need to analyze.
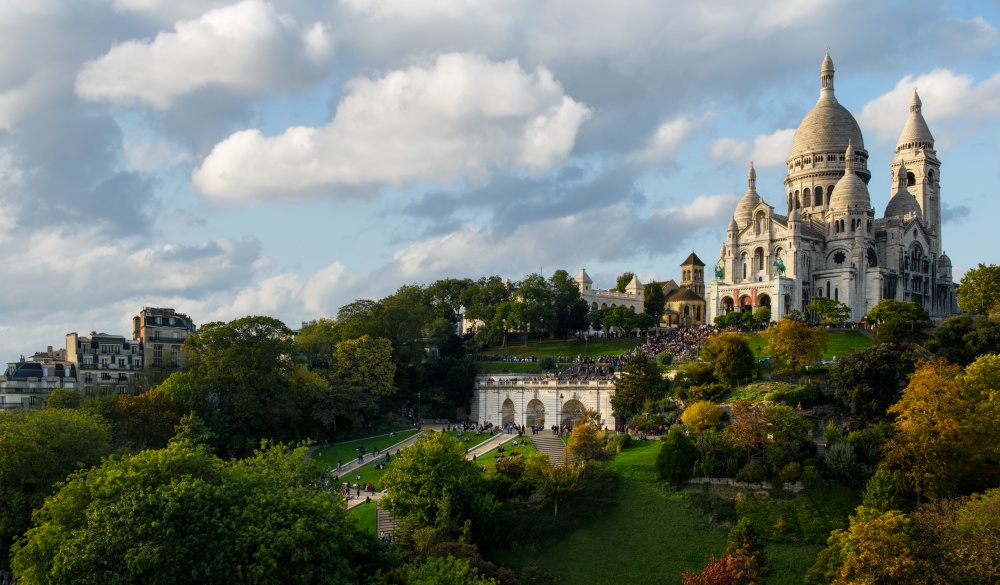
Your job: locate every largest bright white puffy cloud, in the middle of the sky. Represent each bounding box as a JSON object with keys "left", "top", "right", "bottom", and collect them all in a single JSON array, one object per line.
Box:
[{"left": 192, "top": 54, "right": 590, "bottom": 199}]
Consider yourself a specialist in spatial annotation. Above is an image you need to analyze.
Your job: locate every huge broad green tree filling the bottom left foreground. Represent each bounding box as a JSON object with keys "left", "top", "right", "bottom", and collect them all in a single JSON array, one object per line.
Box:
[{"left": 13, "top": 442, "right": 377, "bottom": 585}]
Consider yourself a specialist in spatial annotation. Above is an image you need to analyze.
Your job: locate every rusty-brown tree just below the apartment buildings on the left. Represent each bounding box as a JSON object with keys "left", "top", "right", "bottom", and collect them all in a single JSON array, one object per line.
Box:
[{"left": 115, "top": 388, "right": 181, "bottom": 451}]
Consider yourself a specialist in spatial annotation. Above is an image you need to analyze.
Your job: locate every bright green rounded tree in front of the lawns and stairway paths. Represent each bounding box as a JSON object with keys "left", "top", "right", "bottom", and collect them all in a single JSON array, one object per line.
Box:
[{"left": 382, "top": 433, "right": 484, "bottom": 526}]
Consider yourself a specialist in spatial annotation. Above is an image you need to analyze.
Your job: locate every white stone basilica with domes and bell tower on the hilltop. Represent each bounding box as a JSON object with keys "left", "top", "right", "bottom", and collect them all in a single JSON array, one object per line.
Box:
[{"left": 705, "top": 54, "right": 958, "bottom": 323}]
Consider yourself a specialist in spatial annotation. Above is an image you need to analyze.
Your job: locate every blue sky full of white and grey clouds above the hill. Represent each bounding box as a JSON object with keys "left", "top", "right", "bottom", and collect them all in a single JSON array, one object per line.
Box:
[{"left": 0, "top": 0, "right": 1000, "bottom": 361}]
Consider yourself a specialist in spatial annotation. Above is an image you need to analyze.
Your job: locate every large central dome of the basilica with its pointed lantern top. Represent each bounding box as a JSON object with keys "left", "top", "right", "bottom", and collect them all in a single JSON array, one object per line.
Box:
[{"left": 789, "top": 55, "right": 865, "bottom": 158}]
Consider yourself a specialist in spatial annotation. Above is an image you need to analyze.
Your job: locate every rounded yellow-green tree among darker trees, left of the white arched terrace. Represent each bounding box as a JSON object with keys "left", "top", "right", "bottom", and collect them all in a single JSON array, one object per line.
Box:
[{"left": 334, "top": 335, "right": 396, "bottom": 399}]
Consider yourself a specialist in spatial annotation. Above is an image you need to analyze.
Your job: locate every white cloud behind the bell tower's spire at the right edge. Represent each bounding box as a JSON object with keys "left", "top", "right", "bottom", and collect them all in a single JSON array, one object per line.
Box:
[{"left": 858, "top": 69, "right": 1000, "bottom": 148}]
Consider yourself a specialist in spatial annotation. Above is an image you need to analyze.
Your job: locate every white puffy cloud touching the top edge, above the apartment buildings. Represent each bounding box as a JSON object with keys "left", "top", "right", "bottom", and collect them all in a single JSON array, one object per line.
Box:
[{"left": 76, "top": 0, "right": 333, "bottom": 109}]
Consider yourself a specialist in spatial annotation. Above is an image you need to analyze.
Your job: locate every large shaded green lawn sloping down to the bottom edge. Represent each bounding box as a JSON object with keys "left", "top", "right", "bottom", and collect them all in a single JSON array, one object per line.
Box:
[{"left": 493, "top": 441, "right": 819, "bottom": 585}]
